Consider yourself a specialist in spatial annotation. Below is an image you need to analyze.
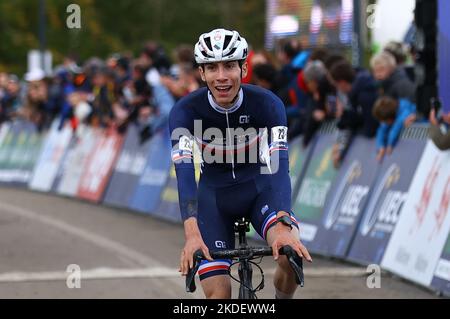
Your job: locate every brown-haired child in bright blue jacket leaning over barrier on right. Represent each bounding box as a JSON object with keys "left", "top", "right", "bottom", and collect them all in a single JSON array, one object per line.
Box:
[{"left": 373, "top": 96, "right": 416, "bottom": 161}]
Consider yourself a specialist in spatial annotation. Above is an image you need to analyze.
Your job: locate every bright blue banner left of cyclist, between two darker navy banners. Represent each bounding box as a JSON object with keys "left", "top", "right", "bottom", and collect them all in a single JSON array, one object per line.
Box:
[{"left": 130, "top": 128, "right": 172, "bottom": 214}]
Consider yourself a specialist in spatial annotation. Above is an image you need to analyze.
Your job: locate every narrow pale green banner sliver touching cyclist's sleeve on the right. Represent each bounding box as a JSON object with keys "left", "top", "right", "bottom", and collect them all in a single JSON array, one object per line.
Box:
[{"left": 289, "top": 136, "right": 313, "bottom": 201}]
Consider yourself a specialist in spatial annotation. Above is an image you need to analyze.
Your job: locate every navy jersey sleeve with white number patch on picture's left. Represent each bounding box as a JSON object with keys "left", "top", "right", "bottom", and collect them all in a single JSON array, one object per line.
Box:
[{"left": 169, "top": 104, "right": 198, "bottom": 221}]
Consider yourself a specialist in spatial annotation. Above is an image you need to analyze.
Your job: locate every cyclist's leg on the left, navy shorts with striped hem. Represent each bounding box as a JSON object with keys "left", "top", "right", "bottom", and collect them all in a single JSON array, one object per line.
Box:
[{"left": 198, "top": 182, "right": 234, "bottom": 299}]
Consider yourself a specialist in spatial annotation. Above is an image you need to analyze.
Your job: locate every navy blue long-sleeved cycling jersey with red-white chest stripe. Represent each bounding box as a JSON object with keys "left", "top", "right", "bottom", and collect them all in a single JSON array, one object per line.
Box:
[{"left": 169, "top": 85, "right": 291, "bottom": 220}]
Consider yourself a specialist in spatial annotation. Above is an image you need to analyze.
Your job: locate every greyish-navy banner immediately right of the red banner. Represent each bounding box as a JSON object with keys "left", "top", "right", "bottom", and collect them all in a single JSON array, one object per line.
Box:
[{"left": 103, "top": 124, "right": 151, "bottom": 208}]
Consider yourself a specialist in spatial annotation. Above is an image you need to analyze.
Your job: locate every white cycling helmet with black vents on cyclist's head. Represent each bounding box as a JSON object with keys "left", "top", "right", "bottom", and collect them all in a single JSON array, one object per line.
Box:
[{"left": 194, "top": 29, "right": 248, "bottom": 64}]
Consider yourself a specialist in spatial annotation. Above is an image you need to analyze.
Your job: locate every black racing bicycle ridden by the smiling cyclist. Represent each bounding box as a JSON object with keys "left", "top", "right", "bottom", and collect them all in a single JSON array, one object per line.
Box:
[{"left": 186, "top": 218, "right": 304, "bottom": 299}]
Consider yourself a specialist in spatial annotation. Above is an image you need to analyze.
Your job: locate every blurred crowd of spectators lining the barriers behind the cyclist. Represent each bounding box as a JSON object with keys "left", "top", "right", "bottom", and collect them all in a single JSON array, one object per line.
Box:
[{"left": 0, "top": 38, "right": 450, "bottom": 155}]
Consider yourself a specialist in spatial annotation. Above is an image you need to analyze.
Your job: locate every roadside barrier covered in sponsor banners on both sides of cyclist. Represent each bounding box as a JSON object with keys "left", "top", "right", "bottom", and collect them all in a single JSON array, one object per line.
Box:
[{"left": 0, "top": 121, "right": 450, "bottom": 295}]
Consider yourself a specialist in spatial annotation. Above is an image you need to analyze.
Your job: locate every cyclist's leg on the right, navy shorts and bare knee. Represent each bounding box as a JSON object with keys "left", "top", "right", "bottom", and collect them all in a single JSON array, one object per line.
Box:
[{"left": 251, "top": 178, "right": 299, "bottom": 298}]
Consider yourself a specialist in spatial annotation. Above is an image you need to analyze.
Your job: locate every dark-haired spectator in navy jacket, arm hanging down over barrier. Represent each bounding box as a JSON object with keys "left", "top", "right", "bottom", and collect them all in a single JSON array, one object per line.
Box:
[{"left": 329, "top": 60, "right": 378, "bottom": 167}]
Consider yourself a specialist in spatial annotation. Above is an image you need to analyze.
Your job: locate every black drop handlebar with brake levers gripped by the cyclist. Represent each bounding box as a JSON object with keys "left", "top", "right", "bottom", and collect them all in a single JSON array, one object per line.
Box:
[{"left": 186, "top": 246, "right": 304, "bottom": 292}]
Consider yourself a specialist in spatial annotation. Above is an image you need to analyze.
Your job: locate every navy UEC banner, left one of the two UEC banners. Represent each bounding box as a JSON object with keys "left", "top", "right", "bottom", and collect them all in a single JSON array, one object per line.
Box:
[{"left": 309, "top": 136, "right": 379, "bottom": 257}]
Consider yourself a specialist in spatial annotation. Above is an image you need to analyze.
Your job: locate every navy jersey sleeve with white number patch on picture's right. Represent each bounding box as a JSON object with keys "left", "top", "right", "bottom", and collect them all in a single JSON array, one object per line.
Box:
[{"left": 267, "top": 97, "right": 291, "bottom": 213}]
